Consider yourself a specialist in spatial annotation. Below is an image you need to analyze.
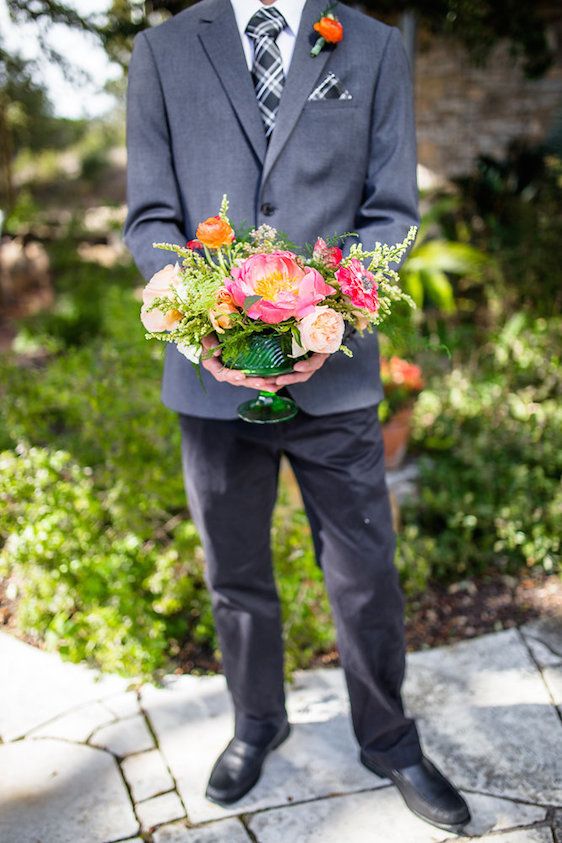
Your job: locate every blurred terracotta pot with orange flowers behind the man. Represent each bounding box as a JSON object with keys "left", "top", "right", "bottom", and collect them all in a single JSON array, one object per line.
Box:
[{"left": 379, "top": 357, "right": 424, "bottom": 469}]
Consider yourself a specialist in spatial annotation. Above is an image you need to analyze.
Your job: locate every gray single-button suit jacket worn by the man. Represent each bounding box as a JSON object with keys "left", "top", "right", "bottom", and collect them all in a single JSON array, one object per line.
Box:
[{"left": 124, "top": 0, "right": 418, "bottom": 419}]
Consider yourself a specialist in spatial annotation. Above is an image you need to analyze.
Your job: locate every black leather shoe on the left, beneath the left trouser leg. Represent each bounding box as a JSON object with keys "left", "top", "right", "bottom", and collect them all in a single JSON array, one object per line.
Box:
[{"left": 205, "top": 721, "right": 291, "bottom": 804}]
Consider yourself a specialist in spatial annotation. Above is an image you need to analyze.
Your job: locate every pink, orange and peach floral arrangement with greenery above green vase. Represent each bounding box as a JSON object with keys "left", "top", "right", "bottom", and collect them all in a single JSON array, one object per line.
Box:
[{"left": 141, "top": 194, "right": 416, "bottom": 372}]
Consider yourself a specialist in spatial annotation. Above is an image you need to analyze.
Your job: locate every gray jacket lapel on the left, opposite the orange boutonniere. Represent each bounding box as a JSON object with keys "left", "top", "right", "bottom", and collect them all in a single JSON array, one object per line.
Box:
[{"left": 199, "top": 0, "right": 267, "bottom": 162}]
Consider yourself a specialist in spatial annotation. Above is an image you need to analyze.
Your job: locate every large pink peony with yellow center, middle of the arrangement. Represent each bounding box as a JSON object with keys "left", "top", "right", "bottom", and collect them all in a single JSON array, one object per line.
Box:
[{"left": 225, "top": 251, "right": 335, "bottom": 325}]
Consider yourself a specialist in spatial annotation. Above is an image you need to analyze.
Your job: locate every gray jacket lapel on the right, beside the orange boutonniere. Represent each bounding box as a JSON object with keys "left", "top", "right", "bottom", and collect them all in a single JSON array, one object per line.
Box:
[{"left": 262, "top": 0, "right": 330, "bottom": 184}]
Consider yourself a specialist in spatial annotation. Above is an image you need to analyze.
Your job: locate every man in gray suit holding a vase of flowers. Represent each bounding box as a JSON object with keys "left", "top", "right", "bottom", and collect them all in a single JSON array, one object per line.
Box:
[{"left": 124, "top": 0, "right": 469, "bottom": 827}]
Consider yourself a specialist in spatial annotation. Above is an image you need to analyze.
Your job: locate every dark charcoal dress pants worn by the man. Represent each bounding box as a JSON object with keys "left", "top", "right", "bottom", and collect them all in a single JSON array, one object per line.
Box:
[{"left": 179, "top": 405, "right": 422, "bottom": 766}]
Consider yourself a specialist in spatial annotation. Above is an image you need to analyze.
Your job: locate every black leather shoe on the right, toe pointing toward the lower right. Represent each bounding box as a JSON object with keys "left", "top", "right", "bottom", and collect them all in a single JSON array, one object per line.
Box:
[{"left": 361, "top": 752, "right": 470, "bottom": 831}]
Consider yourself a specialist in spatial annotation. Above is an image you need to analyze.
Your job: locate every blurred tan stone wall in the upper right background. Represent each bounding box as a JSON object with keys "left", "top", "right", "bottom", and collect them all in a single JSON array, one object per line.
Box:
[{"left": 415, "top": 30, "right": 562, "bottom": 177}]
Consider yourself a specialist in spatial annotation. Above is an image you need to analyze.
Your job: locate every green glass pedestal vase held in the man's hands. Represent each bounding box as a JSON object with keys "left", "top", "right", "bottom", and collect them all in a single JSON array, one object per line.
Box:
[{"left": 223, "top": 332, "right": 302, "bottom": 424}]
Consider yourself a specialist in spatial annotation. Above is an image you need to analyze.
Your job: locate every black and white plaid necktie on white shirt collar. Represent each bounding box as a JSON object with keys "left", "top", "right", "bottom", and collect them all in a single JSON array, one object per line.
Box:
[{"left": 246, "top": 6, "right": 287, "bottom": 139}]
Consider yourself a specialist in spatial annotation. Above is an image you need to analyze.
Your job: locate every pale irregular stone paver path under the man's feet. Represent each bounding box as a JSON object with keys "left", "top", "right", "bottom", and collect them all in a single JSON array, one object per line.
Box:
[{"left": 0, "top": 619, "right": 562, "bottom": 843}]
